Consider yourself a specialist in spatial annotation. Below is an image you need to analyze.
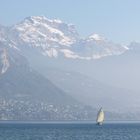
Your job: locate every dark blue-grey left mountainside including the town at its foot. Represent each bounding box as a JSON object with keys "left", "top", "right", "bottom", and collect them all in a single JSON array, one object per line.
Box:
[{"left": 0, "top": 44, "right": 99, "bottom": 120}]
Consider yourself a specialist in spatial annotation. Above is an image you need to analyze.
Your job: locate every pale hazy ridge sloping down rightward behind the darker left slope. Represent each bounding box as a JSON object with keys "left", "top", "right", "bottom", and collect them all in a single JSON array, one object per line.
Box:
[{"left": 31, "top": 67, "right": 140, "bottom": 113}]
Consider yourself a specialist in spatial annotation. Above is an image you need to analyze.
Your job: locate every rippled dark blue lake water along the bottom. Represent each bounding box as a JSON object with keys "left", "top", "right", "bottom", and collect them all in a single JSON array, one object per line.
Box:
[{"left": 0, "top": 122, "right": 140, "bottom": 140}]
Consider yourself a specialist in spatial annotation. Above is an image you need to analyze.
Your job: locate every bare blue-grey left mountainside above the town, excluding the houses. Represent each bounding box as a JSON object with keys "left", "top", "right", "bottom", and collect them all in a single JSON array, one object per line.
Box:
[{"left": 0, "top": 43, "right": 74, "bottom": 103}]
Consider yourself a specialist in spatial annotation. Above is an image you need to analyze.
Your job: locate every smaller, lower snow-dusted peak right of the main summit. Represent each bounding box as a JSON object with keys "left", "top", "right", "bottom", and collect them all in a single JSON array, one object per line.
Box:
[{"left": 71, "top": 34, "right": 128, "bottom": 60}]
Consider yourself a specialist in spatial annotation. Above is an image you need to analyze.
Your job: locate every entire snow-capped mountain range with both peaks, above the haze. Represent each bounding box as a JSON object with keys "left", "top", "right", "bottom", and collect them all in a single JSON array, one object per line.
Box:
[{"left": 0, "top": 16, "right": 128, "bottom": 60}]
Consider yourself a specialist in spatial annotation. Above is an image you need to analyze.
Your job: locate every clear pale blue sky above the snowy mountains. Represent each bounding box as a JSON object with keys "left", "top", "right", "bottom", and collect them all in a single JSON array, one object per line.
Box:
[{"left": 0, "top": 0, "right": 140, "bottom": 43}]
